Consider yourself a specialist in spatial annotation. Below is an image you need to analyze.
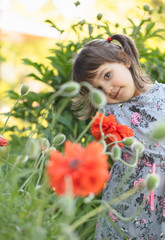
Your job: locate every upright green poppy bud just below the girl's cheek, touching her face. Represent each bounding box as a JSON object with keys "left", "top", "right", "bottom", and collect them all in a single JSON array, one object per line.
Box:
[{"left": 90, "top": 88, "right": 107, "bottom": 108}]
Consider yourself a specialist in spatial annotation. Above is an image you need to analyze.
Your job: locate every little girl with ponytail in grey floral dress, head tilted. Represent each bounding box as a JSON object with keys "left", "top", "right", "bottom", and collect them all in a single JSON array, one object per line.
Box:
[{"left": 73, "top": 34, "right": 165, "bottom": 240}]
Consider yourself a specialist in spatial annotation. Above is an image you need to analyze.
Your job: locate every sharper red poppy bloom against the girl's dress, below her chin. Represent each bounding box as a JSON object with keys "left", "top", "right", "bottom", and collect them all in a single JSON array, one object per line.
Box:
[{"left": 91, "top": 113, "right": 134, "bottom": 147}]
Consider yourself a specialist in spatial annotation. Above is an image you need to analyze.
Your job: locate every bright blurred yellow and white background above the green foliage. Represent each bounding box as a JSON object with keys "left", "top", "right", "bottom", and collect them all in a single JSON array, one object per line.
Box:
[{"left": 0, "top": 0, "right": 165, "bottom": 117}]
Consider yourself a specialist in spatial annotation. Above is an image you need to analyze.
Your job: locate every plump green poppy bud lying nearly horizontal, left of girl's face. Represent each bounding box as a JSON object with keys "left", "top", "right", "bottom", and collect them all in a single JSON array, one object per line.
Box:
[{"left": 60, "top": 81, "right": 80, "bottom": 97}]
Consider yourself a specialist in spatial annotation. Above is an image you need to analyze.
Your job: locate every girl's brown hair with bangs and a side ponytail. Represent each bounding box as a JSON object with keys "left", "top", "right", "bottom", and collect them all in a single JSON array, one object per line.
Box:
[{"left": 72, "top": 34, "right": 151, "bottom": 119}]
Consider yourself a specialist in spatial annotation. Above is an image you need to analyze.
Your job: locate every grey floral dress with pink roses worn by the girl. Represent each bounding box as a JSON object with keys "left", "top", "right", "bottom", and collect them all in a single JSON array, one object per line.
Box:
[{"left": 94, "top": 82, "right": 165, "bottom": 240}]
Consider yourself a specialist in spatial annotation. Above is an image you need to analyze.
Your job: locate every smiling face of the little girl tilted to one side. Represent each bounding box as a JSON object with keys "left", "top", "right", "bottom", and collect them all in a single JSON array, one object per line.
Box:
[{"left": 90, "top": 63, "right": 141, "bottom": 104}]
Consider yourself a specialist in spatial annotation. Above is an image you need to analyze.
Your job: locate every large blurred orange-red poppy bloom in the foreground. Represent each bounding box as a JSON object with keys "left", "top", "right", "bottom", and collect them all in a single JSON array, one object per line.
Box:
[{"left": 47, "top": 141, "right": 109, "bottom": 196}]
